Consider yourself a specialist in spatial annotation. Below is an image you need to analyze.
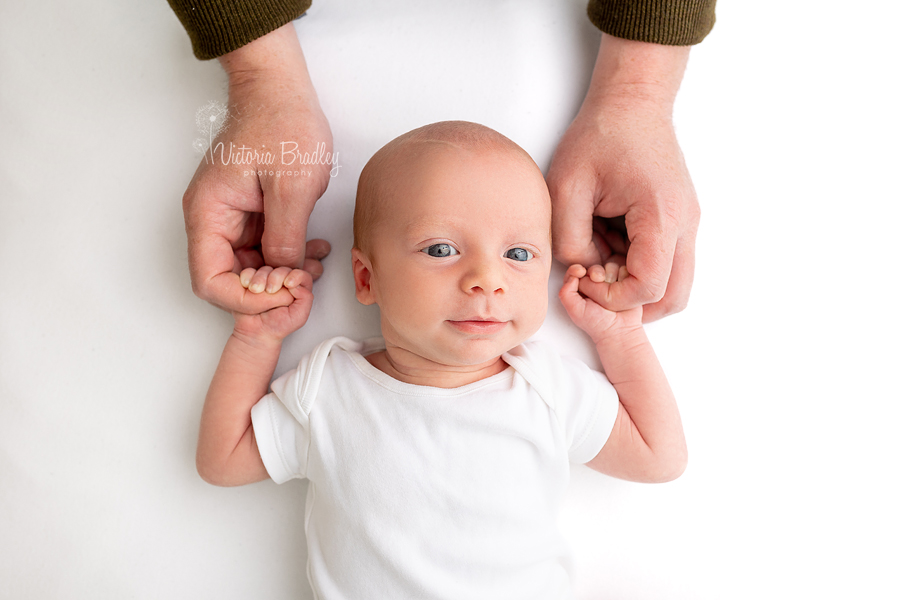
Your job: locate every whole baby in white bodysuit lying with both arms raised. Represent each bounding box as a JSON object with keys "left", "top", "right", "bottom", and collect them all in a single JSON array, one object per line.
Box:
[{"left": 197, "top": 122, "right": 687, "bottom": 600}]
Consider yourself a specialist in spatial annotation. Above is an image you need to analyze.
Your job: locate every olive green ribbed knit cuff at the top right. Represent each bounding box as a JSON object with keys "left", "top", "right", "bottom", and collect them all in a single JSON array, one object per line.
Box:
[{"left": 588, "top": 0, "right": 716, "bottom": 46}]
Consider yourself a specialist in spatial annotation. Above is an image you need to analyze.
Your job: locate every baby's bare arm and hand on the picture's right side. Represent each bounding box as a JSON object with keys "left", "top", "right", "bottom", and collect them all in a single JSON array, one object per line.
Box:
[{"left": 559, "top": 264, "right": 687, "bottom": 482}]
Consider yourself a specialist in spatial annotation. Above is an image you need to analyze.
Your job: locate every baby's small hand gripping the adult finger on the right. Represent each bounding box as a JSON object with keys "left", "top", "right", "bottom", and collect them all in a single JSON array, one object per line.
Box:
[{"left": 559, "top": 256, "right": 643, "bottom": 343}]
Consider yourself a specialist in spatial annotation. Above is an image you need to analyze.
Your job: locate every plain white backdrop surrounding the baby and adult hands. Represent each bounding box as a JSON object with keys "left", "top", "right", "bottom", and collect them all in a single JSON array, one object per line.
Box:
[{"left": 0, "top": 0, "right": 900, "bottom": 600}]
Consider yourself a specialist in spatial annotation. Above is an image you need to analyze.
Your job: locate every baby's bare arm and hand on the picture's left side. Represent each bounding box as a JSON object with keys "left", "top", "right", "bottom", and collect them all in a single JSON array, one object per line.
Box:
[{"left": 197, "top": 267, "right": 312, "bottom": 486}]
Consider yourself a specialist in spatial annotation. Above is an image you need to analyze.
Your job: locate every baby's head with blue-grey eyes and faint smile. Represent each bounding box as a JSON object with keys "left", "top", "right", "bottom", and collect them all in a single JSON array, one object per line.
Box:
[{"left": 353, "top": 121, "right": 552, "bottom": 367}]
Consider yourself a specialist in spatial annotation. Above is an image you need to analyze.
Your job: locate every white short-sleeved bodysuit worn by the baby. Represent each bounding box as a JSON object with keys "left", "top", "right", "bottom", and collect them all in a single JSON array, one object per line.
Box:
[{"left": 252, "top": 338, "right": 619, "bottom": 600}]
